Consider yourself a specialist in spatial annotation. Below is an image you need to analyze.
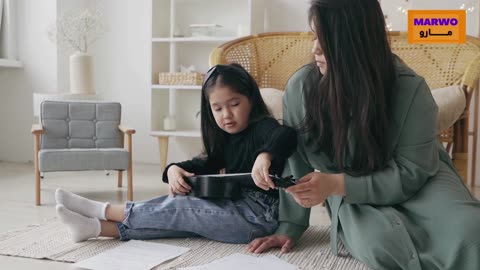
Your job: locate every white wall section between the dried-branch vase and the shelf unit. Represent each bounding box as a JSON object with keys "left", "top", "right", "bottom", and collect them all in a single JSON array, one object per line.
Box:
[{"left": 95, "top": 0, "right": 159, "bottom": 163}]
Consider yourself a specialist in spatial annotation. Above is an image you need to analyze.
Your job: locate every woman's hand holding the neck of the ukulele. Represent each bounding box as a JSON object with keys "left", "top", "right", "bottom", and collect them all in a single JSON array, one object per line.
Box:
[{"left": 285, "top": 172, "right": 345, "bottom": 208}]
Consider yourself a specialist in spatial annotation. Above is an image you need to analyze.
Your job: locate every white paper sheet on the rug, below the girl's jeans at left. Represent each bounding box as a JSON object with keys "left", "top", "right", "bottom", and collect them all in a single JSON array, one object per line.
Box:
[{"left": 73, "top": 240, "right": 190, "bottom": 270}]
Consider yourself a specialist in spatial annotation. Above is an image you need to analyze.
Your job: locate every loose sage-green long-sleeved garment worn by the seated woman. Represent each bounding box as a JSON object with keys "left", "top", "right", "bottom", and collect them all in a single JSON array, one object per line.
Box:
[{"left": 276, "top": 60, "right": 480, "bottom": 269}]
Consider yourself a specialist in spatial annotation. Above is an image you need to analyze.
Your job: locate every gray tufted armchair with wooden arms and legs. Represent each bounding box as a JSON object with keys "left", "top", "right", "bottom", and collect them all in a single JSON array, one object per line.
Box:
[{"left": 32, "top": 101, "right": 135, "bottom": 205}]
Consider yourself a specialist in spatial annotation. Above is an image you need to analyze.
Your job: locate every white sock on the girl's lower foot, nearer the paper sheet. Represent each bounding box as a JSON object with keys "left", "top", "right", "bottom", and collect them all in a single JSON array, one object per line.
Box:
[{"left": 56, "top": 204, "right": 101, "bottom": 243}]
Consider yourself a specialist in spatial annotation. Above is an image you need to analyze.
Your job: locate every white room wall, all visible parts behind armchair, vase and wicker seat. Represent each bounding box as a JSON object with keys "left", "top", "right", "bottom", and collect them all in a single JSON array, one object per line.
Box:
[{"left": 0, "top": 0, "right": 480, "bottom": 184}]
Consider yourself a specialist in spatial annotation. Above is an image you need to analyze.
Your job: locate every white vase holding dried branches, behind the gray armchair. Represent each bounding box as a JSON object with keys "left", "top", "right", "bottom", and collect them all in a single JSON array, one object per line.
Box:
[{"left": 70, "top": 52, "right": 95, "bottom": 95}]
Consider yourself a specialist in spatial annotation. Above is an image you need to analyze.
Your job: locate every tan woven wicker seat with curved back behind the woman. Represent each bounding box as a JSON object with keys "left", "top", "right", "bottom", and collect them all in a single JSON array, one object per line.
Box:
[{"left": 210, "top": 32, "right": 480, "bottom": 186}]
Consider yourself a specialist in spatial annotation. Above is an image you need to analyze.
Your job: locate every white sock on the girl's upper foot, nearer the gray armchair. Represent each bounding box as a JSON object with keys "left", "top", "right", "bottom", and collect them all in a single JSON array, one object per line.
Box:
[{"left": 55, "top": 188, "right": 109, "bottom": 220}]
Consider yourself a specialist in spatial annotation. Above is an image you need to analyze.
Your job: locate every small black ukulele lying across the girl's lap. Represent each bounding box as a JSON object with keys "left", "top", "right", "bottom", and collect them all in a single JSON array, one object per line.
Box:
[{"left": 185, "top": 173, "right": 296, "bottom": 199}]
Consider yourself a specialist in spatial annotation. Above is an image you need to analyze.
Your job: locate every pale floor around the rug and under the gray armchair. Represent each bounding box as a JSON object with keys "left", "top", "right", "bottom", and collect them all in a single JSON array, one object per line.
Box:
[{"left": 0, "top": 162, "right": 480, "bottom": 270}]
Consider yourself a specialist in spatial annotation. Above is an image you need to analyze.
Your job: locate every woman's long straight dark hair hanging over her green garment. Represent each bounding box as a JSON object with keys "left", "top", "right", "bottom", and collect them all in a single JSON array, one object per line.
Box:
[{"left": 300, "top": 0, "right": 395, "bottom": 176}]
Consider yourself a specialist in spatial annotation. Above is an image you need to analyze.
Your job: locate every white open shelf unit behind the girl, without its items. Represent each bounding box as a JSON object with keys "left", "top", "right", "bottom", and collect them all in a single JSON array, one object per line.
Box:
[{"left": 150, "top": 0, "right": 265, "bottom": 171}]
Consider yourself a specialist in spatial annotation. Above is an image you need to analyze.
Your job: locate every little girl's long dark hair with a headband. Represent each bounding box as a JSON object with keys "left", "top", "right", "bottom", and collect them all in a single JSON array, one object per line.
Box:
[{"left": 200, "top": 64, "right": 271, "bottom": 168}]
